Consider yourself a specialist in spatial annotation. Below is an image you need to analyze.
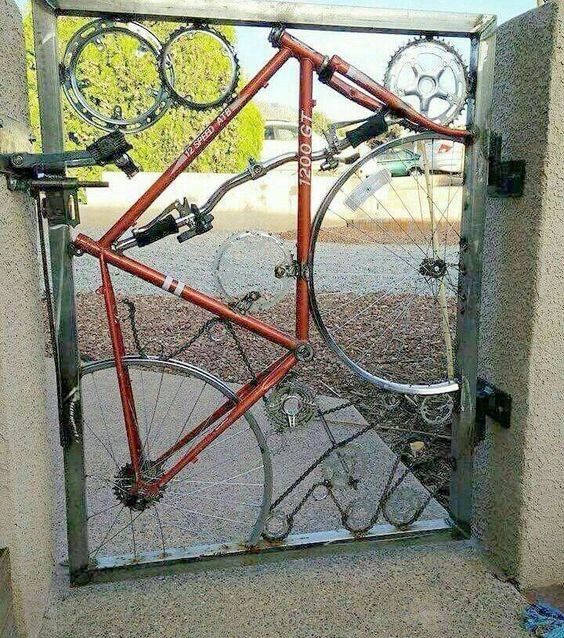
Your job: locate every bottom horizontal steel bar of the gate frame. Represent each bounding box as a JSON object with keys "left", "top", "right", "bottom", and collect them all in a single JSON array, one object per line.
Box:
[{"left": 77, "top": 519, "right": 462, "bottom": 585}]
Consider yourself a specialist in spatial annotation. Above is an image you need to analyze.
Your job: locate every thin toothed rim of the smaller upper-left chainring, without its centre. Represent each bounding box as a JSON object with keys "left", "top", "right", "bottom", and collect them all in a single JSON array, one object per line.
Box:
[{"left": 159, "top": 25, "right": 240, "bottom": 111}]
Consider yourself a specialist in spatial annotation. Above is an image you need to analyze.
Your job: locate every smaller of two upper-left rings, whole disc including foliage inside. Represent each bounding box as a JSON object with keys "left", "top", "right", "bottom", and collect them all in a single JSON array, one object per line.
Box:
[{"left": 159, "top": 25, "right": 240, "bottom": 111}]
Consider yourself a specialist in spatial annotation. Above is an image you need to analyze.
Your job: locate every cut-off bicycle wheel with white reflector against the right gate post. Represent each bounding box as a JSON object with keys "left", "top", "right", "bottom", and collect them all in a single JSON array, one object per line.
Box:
[{"left": 309, "top": 133, "right": 464, "bottom": 395}]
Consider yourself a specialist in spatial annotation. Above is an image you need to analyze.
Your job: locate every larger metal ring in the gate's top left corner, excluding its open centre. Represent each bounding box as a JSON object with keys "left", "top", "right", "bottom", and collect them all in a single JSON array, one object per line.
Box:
[{"left": 62, "top": 19, "right": 174, "bottom": 133}]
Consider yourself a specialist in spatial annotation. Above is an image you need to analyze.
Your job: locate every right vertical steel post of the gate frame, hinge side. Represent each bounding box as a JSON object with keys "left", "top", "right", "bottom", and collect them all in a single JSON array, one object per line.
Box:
[{"left": 450, "top": 20, "right": 496, "bottom": 532}]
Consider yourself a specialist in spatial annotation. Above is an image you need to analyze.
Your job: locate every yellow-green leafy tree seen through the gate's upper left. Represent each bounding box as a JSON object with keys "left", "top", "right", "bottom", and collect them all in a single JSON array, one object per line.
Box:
[{"left": 24, "top": 11, "right": 264, "bottom": 179}]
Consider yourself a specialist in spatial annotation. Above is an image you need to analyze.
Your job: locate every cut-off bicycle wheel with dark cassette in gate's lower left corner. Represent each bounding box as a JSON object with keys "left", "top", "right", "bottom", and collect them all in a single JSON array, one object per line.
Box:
[{"left": 82, "top": 357, "right": 272, "bottom": 561}]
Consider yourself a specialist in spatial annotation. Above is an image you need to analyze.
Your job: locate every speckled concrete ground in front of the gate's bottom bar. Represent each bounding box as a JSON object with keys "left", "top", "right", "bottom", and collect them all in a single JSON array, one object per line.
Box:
[{"left": 41, "top": 542, "right": 529, "bottom": 638}]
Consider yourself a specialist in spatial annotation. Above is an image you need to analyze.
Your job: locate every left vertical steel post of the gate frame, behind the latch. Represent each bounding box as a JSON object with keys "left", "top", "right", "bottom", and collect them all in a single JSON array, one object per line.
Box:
[{"left": 32, "top": 0, "right": 88, "bottom": 583}]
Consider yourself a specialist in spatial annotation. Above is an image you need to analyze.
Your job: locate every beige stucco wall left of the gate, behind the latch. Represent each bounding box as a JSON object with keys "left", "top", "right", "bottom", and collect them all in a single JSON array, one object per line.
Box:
[{"left": 0, "top": 0, "right": 53, "bottom": 636}]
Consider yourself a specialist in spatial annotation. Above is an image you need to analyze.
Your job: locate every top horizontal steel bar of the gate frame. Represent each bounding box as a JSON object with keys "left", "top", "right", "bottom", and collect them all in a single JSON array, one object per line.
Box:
[{"left": 52, "top": 0, "right": 492, "bottom": 36}]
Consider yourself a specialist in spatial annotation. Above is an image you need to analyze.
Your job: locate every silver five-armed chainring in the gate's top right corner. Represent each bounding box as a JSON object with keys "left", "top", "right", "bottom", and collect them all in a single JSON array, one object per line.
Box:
[{"left": 384, "top": 39, "right": 469, "bottom": 125}]
